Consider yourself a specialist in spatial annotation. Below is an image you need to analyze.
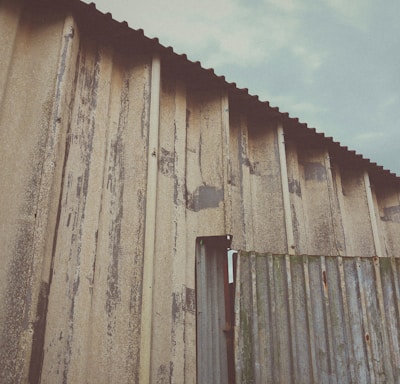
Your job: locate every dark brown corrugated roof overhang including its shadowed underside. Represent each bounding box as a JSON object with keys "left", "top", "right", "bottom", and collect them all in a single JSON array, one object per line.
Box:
[{"left": 57, "top": 0, "right": 400, "bottom": 185}]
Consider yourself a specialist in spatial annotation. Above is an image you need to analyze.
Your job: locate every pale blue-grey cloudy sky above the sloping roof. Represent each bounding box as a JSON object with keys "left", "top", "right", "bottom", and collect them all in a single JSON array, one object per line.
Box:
[{"left": 86, "top": 0, "right": 400, "bottom": 175}]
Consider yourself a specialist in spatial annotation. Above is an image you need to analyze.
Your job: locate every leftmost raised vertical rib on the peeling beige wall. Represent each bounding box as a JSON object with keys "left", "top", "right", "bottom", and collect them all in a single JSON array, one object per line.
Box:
[{"left": 25, "top": 14, "right": 79, "bottom": 382}]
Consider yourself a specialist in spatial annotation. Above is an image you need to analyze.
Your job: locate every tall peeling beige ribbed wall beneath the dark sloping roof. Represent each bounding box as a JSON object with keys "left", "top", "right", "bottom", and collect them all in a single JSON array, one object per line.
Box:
[{"left": 0, "top": 0, "right": 400, "bottom": 383}]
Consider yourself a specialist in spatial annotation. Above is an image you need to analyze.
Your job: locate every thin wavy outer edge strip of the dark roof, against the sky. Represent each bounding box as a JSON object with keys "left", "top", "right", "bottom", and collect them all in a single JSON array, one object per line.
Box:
[{"left": 78, "top": 0, "right": 400, "bottom": 180}]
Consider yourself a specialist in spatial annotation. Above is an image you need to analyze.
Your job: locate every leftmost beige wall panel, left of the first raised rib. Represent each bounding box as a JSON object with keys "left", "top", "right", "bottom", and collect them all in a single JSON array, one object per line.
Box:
[{"left": 0, "top": 2, "right": 68, "bottom": 383}]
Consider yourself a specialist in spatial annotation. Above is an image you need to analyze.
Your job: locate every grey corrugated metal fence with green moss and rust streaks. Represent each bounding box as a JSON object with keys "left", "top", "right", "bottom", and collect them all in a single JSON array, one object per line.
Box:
[{"left": 236, "top": 252, "right": 400, "bottom": 383}]
